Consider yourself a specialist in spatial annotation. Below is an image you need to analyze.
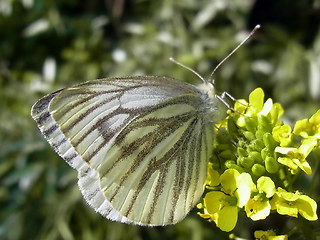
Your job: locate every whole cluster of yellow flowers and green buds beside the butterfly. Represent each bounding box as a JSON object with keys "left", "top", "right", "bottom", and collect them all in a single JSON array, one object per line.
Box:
[{"left": 198, "top": 88, "right": 320, "bottom": 235}]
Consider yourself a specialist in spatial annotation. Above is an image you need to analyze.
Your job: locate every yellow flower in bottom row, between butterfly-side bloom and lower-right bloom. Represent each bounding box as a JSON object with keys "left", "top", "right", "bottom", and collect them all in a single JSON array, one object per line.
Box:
[{"left": 245, "top": 177, "right": 276, "bottom": 221}]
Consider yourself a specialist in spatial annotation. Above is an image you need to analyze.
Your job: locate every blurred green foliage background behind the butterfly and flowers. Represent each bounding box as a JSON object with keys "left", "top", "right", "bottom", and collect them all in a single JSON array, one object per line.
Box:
[{"left": 0, "top": 0, "right": 320, "bottom": 240}]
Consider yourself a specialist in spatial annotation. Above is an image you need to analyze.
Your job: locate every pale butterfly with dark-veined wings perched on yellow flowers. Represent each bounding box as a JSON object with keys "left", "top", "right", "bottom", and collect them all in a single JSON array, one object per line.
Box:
[{"left": 31, "top": 24, "right": 258, "bottom": 226}]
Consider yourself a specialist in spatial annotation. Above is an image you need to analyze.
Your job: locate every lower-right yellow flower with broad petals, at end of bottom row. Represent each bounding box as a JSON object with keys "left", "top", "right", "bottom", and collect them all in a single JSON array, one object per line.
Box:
[{"left": 270, "top": 187, "right": 318, "bottom": 221}]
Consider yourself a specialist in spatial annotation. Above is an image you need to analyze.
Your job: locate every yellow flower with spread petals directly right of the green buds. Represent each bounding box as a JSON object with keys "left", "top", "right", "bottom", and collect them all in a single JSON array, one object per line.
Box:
[{"left": 275, "top": 139, "right": 317, "bottom": 174}]
